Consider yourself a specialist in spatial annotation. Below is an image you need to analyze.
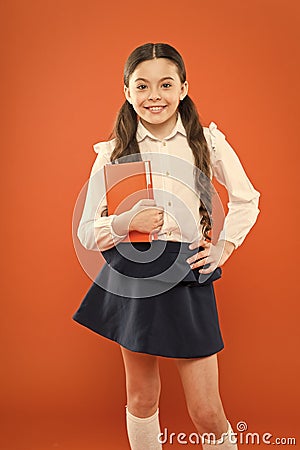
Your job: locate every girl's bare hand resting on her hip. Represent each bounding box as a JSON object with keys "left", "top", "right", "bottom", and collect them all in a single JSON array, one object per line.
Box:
[{"left": 186, "top": 239, "right": 235, "bottom": 273}]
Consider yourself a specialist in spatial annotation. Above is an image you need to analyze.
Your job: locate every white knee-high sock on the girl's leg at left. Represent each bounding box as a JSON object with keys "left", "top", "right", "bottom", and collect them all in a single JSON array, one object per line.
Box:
[{"left": 125, "top": 405, "right": 162, "bottom": 450}]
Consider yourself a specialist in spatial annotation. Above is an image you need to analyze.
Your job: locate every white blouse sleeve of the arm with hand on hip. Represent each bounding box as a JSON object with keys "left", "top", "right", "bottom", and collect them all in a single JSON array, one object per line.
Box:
[{"left": 208, "top": 122, "right": 260, "bottom": 248}]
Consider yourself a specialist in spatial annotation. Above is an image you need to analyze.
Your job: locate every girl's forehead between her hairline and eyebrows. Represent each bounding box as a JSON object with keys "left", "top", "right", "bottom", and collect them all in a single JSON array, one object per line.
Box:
[{"left": 130, "top": 58, "right": 179, "bottom": 82}]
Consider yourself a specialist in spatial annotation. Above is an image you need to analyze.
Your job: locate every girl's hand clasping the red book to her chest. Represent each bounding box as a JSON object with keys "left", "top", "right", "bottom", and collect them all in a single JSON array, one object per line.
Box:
[{"left": 129, "top": 199, "right": 164, "bottom": 234}]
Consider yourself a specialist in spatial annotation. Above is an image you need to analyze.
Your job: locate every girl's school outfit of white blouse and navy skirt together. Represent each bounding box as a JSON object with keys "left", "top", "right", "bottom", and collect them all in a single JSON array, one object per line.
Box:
[{"left": 73, "top": 114, "right": 260, "bottom": 358}]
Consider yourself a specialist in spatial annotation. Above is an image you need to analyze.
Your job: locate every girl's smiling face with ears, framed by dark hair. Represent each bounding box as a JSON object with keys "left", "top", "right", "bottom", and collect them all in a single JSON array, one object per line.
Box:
[{"left": 124, "top": 58, "right": 188, "bottom": 135}]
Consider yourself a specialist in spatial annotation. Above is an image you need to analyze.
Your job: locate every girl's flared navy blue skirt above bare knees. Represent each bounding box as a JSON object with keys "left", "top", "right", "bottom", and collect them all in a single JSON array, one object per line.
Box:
[{"left": 72, "top": 240, "right": 224, "bottom": 358}]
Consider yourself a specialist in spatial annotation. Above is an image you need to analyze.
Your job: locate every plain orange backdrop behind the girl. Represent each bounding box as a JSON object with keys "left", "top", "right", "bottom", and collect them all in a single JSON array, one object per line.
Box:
[{"left": 0, "top": 0, "right": 300, "bottom": 450}]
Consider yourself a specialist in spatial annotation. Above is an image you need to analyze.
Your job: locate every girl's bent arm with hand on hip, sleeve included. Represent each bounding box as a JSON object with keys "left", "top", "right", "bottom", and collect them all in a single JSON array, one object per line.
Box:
[{"left": 187, "top": 122, "right": 260, "bottom": 274}]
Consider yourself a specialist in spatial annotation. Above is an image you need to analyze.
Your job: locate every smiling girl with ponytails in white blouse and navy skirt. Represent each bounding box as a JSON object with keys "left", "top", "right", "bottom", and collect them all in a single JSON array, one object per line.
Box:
[{"left": 73, "top": 43, "right": 260, "bottom": 450}]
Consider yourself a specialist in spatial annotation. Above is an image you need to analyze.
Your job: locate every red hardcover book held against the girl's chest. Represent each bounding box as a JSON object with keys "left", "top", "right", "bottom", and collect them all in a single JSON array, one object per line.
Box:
[{"left": 104, "top": 161, "right": 157, "bottom": 242}]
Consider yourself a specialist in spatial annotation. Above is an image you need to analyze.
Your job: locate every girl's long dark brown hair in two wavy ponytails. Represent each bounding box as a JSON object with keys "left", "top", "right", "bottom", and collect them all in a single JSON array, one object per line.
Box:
[{"left": 106, "top": 43, "right": 212, "bottom": 240}]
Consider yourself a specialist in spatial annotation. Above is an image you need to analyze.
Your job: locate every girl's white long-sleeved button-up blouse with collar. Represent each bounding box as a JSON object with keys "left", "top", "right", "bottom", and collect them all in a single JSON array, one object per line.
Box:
[{"left": 77, "top": 114, "right": 260, "bottom": 251}]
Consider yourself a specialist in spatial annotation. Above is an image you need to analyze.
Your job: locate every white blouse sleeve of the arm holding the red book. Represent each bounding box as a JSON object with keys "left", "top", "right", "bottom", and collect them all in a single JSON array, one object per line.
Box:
[{"left": 77, "top": 142, "right": 127, "bottom": 251}]
